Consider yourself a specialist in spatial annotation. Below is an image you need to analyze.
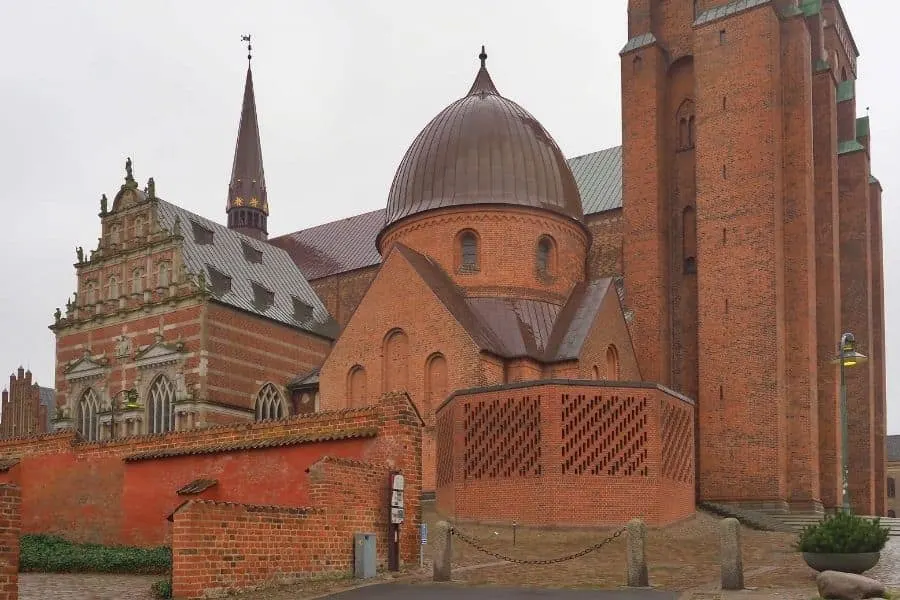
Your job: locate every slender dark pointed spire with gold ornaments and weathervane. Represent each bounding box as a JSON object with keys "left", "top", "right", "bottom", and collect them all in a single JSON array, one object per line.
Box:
[{"left": 225, "top": 35, "right": 269, "bottom": 240}]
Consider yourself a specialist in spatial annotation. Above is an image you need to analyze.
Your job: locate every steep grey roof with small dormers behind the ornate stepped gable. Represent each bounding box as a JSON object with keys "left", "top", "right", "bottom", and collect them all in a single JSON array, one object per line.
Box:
[{"left": 157, "top": 200, "right": 338, "bottom": 339}]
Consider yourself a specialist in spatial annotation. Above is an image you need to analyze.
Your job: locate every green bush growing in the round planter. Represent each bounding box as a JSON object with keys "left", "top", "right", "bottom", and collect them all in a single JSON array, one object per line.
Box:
[{"left": 797, "top": 513, "right": 889, "bottom": 554}]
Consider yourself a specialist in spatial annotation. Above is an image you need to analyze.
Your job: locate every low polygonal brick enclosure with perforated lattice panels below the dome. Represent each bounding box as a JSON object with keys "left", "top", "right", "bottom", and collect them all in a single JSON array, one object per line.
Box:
[{"left": 436, "top": 380, "right": 695, "bottom": 526}]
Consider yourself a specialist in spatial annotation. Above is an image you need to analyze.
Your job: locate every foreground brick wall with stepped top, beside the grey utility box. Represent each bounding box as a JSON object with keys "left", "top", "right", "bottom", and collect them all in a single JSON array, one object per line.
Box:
[{"left": 172, "top": 457, "right": 408, "bottom": 600}]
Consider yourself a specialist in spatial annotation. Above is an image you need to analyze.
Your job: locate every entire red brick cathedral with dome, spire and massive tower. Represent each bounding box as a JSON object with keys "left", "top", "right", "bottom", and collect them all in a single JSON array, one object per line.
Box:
[{"left": 51, "top": 0, "right": 885, "bottom": 523}]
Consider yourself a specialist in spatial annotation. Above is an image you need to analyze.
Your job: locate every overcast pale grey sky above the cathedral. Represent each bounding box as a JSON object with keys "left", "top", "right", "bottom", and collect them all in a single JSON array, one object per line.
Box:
[{"left": 0, "top": 0, "right": 900, "bottom": 433}]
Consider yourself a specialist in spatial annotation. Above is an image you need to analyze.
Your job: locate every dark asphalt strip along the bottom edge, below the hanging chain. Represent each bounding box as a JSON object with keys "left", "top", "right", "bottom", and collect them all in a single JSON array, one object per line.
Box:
[{"left": 328, "top": 583, "right": 678, "bottom": 600}]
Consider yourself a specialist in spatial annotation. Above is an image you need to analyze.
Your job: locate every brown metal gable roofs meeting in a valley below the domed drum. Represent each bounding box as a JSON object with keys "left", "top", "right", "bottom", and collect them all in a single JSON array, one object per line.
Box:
[{"left": 395, "top": 244, "right": 612, "bottom": 362}]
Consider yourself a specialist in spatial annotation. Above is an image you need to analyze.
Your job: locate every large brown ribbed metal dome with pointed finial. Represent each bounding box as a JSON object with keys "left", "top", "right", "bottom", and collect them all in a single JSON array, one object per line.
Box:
[{"left": 385, "top": 47, "right": 584, "bottom": 232}]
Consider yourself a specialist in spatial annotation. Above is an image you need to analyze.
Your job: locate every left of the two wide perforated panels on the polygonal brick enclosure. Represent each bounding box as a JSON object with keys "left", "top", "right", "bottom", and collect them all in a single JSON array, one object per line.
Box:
[{"left": 463, "top": 396, "right": 541, "bottom": 479}]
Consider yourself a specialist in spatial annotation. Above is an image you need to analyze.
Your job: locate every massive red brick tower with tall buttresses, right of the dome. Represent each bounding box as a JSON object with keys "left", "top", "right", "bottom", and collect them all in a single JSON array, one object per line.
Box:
[{"left": 621, "top": 0, "right": 885, "bottom": 514}]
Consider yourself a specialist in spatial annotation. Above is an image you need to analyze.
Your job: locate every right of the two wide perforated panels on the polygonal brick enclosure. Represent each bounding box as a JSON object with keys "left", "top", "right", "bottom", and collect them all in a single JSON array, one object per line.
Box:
[{"left": 560, "top": 394, "right": 647, "bottom": 477}]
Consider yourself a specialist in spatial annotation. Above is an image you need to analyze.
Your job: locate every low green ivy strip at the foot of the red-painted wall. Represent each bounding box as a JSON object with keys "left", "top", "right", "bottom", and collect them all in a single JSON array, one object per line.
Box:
[{"left": 19, "top": 535, "right": 172, "bottom": 574}]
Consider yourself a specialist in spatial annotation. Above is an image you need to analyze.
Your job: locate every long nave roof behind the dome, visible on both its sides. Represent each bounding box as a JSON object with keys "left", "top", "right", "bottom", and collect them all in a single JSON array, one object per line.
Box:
[{"left": 278, "top": 146, "right": 622, "bottom": 280}]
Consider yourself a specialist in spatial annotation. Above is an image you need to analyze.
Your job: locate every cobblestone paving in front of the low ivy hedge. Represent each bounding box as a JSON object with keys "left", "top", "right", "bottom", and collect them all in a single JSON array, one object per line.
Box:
[{"left": 19, "top": 573, "right": 157, "bottom": 600}]
